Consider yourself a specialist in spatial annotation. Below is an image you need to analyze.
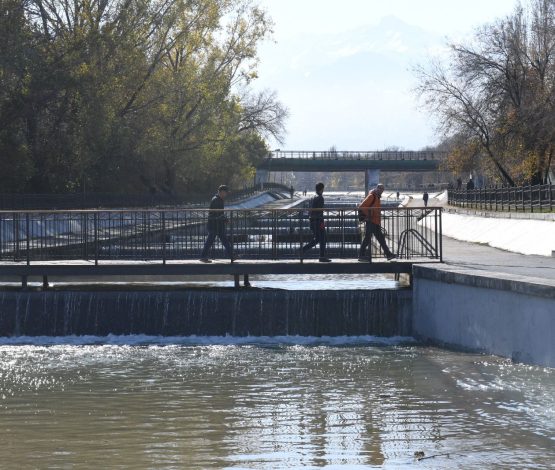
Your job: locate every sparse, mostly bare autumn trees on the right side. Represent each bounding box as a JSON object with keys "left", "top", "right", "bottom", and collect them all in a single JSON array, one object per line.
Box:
[{"left": 416, "top": 0, "right": 555, "bottom": 185}]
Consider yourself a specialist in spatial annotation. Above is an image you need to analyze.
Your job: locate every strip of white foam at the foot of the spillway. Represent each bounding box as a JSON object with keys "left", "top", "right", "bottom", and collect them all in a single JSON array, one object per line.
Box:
[{"left": 0, "top": 335, "right": 417, "bottom": 347}]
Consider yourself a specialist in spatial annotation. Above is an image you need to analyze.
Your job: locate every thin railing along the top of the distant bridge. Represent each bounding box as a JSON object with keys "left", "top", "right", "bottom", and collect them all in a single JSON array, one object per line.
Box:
[{"left": 268, "top": 150, "right": 447, "bottom": 160}]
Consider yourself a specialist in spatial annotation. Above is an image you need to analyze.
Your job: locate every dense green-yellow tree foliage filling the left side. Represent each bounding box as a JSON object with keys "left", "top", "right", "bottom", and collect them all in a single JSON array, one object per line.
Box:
[{"left": 0, "top": 0, "right": 287, "bottom": 192}]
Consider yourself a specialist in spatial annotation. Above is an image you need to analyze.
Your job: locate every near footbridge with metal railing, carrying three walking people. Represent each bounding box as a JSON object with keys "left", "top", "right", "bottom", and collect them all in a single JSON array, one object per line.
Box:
[{"left": 0, "top": 207, "right": 442, "bottom": 287}]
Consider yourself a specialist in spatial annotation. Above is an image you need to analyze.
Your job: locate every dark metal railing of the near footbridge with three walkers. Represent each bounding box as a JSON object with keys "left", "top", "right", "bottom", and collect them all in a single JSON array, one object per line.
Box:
[{"left": 0, "top": 208, "right": 442, "bottom": 264}]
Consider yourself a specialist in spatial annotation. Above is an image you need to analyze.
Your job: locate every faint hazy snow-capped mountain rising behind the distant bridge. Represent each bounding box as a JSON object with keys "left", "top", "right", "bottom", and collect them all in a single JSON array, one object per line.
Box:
[{"left": 257, "top": 16, "right": 446, "bottom": 150}]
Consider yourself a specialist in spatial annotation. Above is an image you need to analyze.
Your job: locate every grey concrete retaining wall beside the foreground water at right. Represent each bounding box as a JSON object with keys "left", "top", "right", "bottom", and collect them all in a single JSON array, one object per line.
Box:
[{"left": 413, "top": 266, "right": 555, "bottom": 367}]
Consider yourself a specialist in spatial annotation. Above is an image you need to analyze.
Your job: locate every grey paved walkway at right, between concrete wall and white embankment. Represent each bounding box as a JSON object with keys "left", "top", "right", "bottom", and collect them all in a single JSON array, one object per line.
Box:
[{"left": 443, "top": 236, "right": 555, "bottom": 280}]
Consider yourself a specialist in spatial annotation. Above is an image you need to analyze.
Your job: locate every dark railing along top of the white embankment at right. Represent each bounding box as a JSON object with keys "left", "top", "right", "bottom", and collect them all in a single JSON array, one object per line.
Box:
[{"left": 448, "top": 184, "right": 555, "bottom": 212}]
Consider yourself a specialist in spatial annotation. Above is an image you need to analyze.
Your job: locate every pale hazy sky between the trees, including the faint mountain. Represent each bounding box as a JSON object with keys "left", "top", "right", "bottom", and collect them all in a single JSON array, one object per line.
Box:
[{"left": 255, "top": 0, "right": 526, "bottom": 151}]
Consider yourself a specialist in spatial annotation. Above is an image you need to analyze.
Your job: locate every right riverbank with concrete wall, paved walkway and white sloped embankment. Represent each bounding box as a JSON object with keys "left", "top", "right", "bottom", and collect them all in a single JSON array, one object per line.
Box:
[{"left": 413, "top": 195, "right": 555, "bottom": 367}]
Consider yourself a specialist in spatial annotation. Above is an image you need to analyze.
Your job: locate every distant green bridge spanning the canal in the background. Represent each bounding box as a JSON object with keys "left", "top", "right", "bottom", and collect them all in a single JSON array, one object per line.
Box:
[{"left": 256, "top": 150, "right": 447, "bottom": 189}]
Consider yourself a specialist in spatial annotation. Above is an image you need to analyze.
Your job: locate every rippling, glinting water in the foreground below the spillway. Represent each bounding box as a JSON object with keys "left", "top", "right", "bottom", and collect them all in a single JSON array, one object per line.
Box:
[{"left": 0, "top": 337, "right": 555, "bottom": 469}]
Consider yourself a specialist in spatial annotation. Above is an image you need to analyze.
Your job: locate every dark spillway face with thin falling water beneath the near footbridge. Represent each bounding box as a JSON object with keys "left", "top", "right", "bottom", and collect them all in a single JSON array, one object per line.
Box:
[{"left": 0, "top": 288, "right": 412, "bottom": 336}]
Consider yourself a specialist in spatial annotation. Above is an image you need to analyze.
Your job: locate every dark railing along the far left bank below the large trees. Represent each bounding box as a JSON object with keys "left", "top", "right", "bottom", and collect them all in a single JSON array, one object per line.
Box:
[{"left": 0, "top": 182, "right": 290, "bottom": 210}]
